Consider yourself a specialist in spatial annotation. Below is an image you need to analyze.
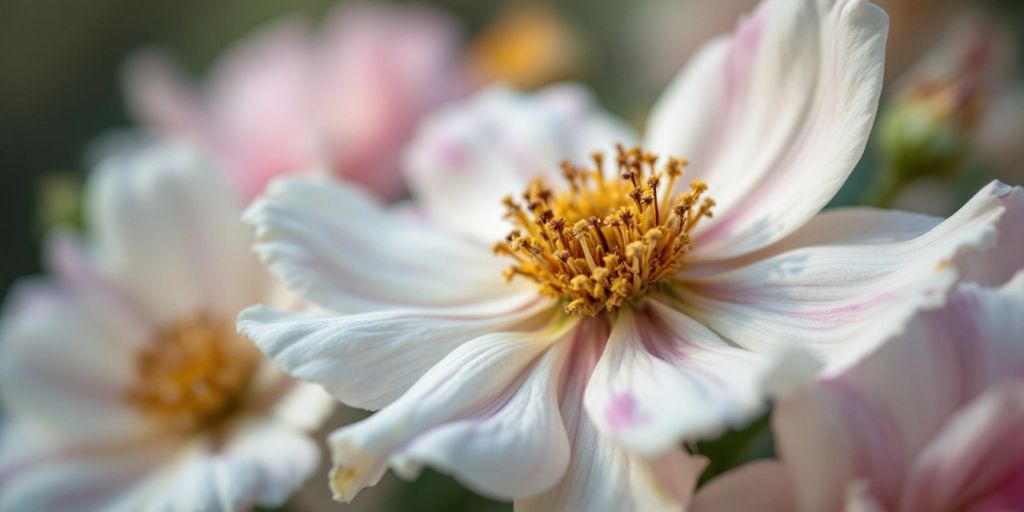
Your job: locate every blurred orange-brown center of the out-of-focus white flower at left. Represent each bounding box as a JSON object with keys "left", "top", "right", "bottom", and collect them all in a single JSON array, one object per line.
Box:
[{"left": 124, "top": 314, "right": 259, "bottom": 432}]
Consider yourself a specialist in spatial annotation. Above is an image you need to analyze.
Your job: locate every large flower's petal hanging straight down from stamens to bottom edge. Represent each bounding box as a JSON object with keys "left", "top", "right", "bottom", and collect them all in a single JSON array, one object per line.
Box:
[{"left": 515, "top": 322, "right": 707, "bottom": 512}]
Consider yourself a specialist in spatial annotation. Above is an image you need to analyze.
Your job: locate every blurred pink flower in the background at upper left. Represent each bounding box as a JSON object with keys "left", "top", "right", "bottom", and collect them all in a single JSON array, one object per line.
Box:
[{"left": 125, "top": 3, "right": 468, "bottom": 200}]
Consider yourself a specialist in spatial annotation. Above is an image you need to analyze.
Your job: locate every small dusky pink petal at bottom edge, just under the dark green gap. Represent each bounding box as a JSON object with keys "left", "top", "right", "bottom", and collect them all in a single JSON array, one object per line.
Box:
[{"left": 689, "top": 461, "right": 797, "bottom": 512}]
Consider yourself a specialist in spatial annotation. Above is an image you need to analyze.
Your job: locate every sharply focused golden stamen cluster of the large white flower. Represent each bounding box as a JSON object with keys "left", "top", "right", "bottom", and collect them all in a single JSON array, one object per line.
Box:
[{"left": 495, "top": 145, "right": 715, "bottom": 316}]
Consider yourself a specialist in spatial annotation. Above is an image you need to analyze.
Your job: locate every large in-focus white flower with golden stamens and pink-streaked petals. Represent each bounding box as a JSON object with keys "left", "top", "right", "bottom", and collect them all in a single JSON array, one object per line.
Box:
[{"left": 240, "top": 0, "right": 1009, "bottom": 511}]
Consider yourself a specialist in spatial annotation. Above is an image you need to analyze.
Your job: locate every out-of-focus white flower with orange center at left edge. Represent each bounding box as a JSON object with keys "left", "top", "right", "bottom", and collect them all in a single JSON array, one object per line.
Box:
[{"left": 0, "top": 148, "right": 332, "bottom": 511}]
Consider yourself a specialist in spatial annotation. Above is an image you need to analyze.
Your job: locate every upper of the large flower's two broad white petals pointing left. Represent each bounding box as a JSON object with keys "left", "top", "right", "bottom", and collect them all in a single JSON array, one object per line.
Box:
[{"left": 246, "top": 178, "right": 525, "bottom": 312}]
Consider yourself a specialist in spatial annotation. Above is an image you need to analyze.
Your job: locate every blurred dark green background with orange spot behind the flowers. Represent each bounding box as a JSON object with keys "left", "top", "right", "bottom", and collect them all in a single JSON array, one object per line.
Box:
[{"left": 0, "top": 0, "right": 1024, "bottom": 511}]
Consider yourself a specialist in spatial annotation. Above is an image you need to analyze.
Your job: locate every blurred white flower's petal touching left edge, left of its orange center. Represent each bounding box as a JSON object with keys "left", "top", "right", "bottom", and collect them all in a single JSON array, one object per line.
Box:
[{"left": 0, "top": 284, "right": 147, "bottom": 439}]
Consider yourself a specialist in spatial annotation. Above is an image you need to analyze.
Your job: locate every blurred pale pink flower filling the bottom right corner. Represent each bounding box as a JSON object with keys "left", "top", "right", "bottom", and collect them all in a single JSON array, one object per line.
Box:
[{"left": 695, "top": 188, "right": 1024, "bottom": 512}]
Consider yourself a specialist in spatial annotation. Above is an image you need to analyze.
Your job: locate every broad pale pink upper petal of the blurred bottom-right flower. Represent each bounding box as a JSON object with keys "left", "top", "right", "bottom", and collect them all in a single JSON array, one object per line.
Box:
[{"left": 774, "top": 272, "right": 1024, "bottom": 510}]
